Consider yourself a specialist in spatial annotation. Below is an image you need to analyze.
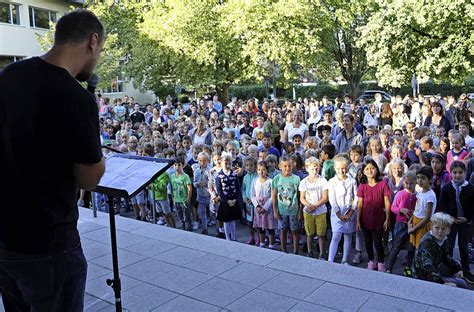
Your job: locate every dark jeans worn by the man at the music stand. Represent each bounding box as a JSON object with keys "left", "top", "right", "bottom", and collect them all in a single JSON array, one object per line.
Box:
[{"left": 0, "top": 245, "right": 87, "bottom": 312}]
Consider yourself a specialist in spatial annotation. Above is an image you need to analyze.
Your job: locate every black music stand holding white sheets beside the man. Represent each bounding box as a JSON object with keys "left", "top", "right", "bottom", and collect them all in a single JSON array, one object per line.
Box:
[{"left": 94, "top": 154, "right": 174, "bottom": 311}]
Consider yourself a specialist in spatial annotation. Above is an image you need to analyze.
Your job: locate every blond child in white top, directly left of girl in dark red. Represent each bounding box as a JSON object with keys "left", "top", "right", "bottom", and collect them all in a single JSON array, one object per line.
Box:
[{"left": 328, "top": 156, "right": 357, "bottom": 265}]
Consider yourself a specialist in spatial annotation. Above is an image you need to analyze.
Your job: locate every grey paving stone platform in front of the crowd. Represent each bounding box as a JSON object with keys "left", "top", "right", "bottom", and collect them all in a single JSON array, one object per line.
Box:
[{"left": 0, "top": 208, "right": 474, "bottom": 312}]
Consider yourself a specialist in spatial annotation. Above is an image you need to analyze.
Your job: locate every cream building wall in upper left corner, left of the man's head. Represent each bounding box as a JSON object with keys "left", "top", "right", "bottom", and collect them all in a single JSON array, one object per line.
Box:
[{"left": 0, "top": 0, "right": 72, "bottom": 57}]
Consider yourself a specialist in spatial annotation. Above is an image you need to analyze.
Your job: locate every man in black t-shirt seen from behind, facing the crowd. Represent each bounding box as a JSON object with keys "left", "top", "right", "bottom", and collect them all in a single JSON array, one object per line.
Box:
[{"left": 0, "top": 9, "right": 105, "bottom": 311}]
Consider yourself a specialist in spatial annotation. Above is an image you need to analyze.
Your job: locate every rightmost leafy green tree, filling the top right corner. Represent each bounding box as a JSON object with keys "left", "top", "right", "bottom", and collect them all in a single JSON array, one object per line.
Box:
[{"left": 360, "top": 0, "right": 474, "bottom": 87}]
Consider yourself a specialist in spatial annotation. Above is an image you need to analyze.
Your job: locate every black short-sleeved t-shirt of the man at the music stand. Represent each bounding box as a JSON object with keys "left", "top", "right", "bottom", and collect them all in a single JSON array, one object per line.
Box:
[{"left": 0, "top": 57, "right": 102, "bottom": 254}]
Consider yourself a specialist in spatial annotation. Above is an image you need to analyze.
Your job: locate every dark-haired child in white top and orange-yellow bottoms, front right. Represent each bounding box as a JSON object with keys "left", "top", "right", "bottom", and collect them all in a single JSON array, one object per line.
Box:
[{"left": 404, "top": 166, "right": 437, "bottom": 276}]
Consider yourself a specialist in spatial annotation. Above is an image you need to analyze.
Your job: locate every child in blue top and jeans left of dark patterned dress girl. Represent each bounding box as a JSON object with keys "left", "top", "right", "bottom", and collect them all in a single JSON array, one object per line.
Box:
[{"left": 193, "top": 152, "right": 211, "bottom": 235}]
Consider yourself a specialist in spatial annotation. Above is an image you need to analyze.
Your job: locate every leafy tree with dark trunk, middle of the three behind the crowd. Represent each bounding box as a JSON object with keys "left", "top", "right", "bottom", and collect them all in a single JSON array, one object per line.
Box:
[{"left": 223, "top": 0, "right": 371, "bottom": 98}]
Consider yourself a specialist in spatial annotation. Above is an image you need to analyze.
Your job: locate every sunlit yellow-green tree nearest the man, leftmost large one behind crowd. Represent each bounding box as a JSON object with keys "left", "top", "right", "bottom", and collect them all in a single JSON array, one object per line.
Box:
[{"left": 140, "top": 0, "right": 255, "bottom": 101}]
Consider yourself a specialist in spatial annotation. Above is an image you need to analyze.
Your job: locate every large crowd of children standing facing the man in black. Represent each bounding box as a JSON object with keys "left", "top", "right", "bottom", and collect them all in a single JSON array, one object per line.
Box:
[{"left": 90, "top": 95, "right": 474, "bottom": 287}]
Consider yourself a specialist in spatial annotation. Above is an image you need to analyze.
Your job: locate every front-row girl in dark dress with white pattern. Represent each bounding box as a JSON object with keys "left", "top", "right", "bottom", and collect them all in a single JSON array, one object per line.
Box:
[{"left": 215, "top": 154, "right": 243, "bottom": 241}]
